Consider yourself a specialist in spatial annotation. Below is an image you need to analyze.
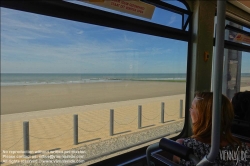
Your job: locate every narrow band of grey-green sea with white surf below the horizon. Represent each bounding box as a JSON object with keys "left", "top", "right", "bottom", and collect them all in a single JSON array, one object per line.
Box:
[{"left": 1, "top": 73, "right": 186, "bottom": 86}]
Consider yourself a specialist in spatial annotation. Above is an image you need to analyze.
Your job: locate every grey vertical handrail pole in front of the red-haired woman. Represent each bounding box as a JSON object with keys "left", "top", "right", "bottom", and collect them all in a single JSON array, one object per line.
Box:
[{"left": 197, "top": 0, "right": 226, "bottom": 165}]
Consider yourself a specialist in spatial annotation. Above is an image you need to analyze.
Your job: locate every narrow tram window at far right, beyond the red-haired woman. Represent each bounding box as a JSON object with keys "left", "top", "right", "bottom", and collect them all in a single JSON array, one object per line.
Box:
[{"left": 222, "top": 21, "right": 250, "bottom": 99}]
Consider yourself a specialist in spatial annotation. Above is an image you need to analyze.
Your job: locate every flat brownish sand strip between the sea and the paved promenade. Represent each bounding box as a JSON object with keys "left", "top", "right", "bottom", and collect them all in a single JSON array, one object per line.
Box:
[{"left": 1, "top": 81, "right": 185, "bottom": 115}]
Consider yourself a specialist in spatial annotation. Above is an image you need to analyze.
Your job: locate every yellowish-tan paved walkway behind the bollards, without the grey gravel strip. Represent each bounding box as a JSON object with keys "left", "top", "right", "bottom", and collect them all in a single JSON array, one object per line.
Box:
[{"left": 1, "top": 95, "right": 185, "bottom": 165}]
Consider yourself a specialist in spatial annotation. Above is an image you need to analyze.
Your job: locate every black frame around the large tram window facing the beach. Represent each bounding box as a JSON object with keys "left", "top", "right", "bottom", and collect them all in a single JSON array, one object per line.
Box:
[{"left": 0, "top": 0, "right": 192, "bottom": 166}]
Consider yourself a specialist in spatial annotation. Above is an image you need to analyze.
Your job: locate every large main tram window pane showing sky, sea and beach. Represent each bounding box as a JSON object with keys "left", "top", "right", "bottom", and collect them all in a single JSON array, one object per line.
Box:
[{"left": 1, "top": 8, "right": 187, "bottom": 165}]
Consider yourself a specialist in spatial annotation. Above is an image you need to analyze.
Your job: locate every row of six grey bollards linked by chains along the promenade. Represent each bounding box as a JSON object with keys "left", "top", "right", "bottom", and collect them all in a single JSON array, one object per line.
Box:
[{"left": 23, "top": 100, "right": 183, "bottom": 156}]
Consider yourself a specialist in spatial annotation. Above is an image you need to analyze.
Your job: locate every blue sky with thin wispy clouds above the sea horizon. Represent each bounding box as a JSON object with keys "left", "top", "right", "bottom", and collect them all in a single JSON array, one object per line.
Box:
[{"left": 1, "top": 0, "right": 250, "bottom": 73}]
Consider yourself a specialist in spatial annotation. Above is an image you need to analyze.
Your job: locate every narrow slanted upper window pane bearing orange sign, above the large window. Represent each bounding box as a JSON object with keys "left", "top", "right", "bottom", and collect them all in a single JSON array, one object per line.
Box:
[{"left": 67, "top": 0, "right": 187, "bottom": 29}]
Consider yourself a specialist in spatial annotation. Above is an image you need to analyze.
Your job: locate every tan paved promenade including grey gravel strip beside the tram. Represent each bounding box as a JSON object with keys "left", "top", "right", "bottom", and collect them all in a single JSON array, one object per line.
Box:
[{"left": 0, "top": 86, "right": 250, "bottom": 166}]
